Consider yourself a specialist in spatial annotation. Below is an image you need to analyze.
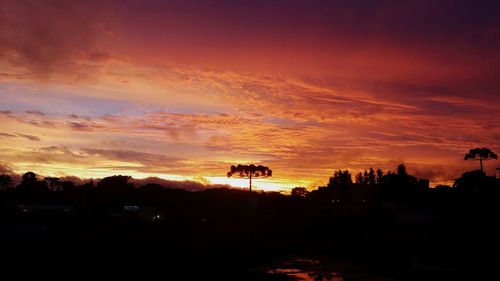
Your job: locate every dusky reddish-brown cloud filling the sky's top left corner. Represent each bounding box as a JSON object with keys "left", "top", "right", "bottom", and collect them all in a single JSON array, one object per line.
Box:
[{"left": 0, "top": 0, "right": 109, "bottom": 77}]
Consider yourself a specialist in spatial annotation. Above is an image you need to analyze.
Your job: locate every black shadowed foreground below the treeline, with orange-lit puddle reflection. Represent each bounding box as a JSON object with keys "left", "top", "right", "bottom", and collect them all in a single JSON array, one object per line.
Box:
[{"left": 0, "top": 185, "right": 500, "bottom": 281}]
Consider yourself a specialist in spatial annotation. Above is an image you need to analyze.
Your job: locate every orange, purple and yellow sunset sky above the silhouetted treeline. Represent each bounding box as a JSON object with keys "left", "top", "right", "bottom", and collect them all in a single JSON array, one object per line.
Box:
[{"left": 0, "top": 0, "right": 500, "bottom": 190}]
